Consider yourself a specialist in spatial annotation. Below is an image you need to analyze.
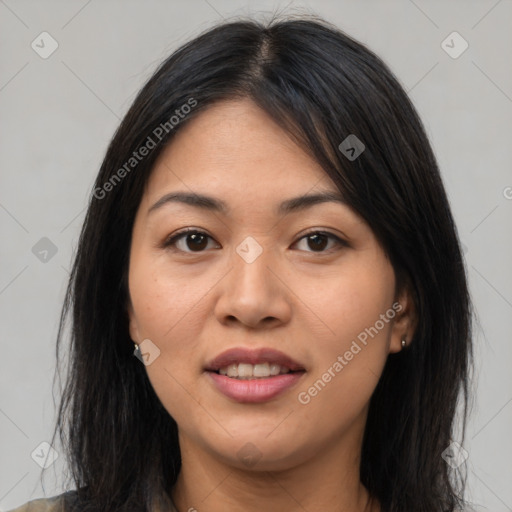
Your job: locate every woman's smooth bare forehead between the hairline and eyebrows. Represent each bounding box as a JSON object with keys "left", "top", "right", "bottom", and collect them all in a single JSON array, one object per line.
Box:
[{"left": 142, "top": 99, "right": 338, "bottom": 200}]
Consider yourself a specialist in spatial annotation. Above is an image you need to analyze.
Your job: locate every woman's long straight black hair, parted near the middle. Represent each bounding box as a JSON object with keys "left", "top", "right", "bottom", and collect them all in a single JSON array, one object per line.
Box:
[{"left": 50, "top": 15, "right": 473, "bottom": 512}]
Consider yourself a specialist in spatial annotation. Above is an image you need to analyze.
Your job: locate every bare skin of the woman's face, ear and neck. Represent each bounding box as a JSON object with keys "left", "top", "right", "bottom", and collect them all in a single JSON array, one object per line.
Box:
[{"left": 129, "top": 99, "right": 414, "bottom": 512}]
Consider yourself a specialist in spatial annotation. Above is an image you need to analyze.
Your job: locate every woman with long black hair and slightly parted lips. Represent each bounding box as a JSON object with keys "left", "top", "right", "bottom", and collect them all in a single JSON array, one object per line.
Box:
[{"left": 8, "top": 12, "right": 472, "bottom": 512}]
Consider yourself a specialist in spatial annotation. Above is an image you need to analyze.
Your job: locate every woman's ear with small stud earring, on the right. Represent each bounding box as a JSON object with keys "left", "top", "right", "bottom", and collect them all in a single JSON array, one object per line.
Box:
[{"left": 389, "top": 281, "right": 418, "bottom": 353}]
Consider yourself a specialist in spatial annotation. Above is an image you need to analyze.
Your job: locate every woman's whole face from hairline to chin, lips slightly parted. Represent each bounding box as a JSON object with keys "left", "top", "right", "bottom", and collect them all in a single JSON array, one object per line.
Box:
[{"left": 129, "top": 100, "right": 409, "bottom": 470}]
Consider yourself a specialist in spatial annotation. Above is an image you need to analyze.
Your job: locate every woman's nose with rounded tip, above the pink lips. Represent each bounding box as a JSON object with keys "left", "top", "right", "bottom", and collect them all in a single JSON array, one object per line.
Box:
[{"left": 214, "top": 241, "right": 291, "bottom": 329}]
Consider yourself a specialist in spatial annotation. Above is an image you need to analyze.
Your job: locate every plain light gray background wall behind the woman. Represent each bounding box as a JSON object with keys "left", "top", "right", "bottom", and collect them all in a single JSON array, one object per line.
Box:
[{"left": 0, "top": 0, "right": 512, "bottom": 512}]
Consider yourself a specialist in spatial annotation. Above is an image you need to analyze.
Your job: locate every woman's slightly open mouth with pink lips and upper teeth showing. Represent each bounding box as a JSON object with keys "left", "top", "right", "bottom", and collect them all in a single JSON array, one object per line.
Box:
[{"left": 205, "top": 348, "right": 306, "bottom": 403}]
